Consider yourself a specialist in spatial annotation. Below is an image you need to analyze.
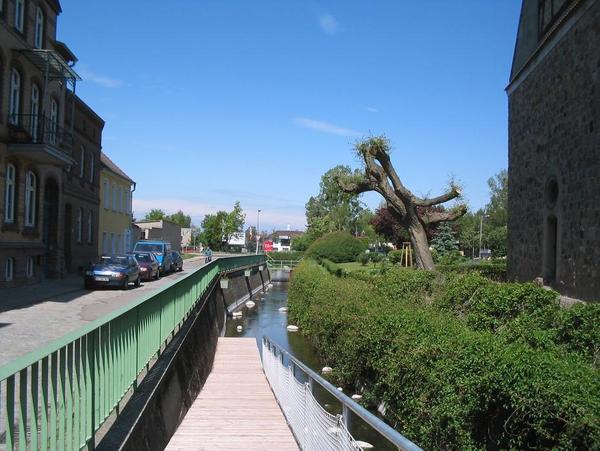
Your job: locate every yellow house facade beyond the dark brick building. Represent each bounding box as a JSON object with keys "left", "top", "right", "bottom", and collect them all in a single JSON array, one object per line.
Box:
[{"left": 98, "top": 153, "right": 135, "bottom": 255}]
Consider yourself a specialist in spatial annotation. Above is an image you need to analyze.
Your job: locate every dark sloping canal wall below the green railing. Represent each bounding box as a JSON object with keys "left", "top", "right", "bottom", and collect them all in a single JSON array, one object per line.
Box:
[{"left": 98, "top": 268, "right": 268, "bottom": 451}]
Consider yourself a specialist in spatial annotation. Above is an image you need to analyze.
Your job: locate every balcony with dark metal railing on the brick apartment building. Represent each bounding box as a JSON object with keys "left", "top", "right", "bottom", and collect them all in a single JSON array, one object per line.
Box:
[{"left": 8, "top": 114, "right": 74, "bottom": 164}]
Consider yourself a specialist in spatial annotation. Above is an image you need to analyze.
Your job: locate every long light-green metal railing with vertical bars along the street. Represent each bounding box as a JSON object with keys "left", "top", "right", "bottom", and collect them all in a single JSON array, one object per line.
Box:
[{"left": 0, "top": 255, "right": 265, "bottom": 450}]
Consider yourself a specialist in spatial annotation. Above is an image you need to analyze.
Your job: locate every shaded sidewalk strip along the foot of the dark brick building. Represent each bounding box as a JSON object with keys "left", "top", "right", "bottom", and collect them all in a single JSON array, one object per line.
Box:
[{"left": 0, "top": 275, "right": 83, "bottom": 312}]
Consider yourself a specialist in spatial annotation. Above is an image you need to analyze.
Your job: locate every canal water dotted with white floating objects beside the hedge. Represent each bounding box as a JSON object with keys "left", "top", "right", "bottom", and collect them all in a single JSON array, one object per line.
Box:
[{"left": 225, "top": 282, "right": 396, "bottom": 450}]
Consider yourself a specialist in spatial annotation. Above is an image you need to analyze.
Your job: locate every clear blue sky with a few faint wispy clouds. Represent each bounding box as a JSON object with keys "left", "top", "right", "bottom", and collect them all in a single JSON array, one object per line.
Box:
[{"left": 58, "top": 0, "right": 520, "bottom": 230}]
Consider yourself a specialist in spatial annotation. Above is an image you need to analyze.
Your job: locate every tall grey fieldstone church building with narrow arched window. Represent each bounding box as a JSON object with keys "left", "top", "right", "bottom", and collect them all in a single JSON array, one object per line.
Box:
[{"left": 507, "top": 0, "right": 600, "bottom": 300}]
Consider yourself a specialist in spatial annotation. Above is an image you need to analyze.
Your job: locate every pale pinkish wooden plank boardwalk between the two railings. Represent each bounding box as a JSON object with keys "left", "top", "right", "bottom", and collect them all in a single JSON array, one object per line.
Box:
[{"left": 166, "top": 338, "right": 298, "bottom": 451}]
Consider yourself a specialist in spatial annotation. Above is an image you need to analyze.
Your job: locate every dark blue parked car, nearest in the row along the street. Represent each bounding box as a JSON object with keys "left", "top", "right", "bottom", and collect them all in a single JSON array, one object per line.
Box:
[{"left": 83, "top": 255, "right": 142, "bottom": 290}]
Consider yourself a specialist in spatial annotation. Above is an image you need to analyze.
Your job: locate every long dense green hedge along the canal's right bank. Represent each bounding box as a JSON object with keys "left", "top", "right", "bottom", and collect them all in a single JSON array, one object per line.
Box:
[{"left": 289, "top": 261, "right": 600, "bottom": 449}]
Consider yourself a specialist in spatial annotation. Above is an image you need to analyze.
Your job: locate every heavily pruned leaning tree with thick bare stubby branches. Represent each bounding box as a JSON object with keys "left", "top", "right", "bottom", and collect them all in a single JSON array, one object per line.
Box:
[{"left": 337, "top": 136, "right": 467, "bottom": 270}]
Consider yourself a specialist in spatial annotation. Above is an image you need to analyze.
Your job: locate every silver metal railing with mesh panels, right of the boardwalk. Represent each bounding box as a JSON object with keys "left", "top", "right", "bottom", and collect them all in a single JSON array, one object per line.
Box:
[{"left": 262, "top": 337, "right": 421, "bottom": 451}]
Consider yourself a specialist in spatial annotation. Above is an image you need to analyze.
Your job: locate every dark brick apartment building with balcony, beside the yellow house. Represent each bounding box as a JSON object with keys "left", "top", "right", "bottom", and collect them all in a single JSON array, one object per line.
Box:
[{"left": 0, "top": 0, "right": 103, "bottom": 288}]
